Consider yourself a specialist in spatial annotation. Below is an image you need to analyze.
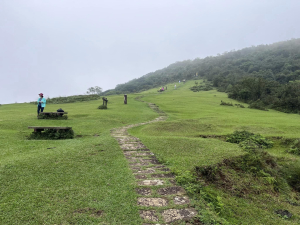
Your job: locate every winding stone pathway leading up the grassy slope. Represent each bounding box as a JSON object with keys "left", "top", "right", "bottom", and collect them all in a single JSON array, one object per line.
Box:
[{"left": 111, "top": 103, "right": 197, "bottom": 225}]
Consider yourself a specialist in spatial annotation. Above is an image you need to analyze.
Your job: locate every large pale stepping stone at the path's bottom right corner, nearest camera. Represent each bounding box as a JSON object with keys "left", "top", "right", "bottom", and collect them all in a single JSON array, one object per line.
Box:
[{"left": 162, "top": 209, "right": 197, "bottom": 223}]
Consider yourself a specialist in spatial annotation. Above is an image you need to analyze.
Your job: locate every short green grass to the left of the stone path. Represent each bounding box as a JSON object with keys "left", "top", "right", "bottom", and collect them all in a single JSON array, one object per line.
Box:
[{"left": 0, "top": 96, "right": 157, "bottom": 225}]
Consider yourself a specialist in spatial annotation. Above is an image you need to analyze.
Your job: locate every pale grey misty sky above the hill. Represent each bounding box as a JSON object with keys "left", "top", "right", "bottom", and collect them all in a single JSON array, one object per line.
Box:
[{"left": 0, "top": 0, "right": 300, "bottom": 104}]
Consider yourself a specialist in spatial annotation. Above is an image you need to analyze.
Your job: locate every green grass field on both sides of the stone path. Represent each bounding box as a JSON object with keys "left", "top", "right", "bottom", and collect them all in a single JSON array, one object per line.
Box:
[{"left": 0, "top": 81, "right": 300, "bottom": 225}]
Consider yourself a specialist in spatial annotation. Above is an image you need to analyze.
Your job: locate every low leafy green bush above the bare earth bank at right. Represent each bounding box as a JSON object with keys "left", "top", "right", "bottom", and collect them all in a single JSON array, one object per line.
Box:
[{"left": 226, "top": 130, "right": 273, "bottom": 150}]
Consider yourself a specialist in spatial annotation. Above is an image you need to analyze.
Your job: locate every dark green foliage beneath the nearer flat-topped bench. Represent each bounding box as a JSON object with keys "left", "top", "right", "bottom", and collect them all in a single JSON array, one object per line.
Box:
[{"left": 28, "top": 129, "right": 74, "bottom": 140}]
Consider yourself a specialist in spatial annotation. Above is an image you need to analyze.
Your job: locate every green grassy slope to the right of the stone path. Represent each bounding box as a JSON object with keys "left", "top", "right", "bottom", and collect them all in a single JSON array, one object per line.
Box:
[{"left": 130, "top": 81, "right": 300, "bottom": 224}]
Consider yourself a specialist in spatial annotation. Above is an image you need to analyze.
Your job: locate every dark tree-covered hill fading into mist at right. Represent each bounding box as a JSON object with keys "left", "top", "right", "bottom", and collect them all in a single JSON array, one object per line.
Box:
[{"left": 103, "top": 39, "right": 300, "bottom": 113}]
